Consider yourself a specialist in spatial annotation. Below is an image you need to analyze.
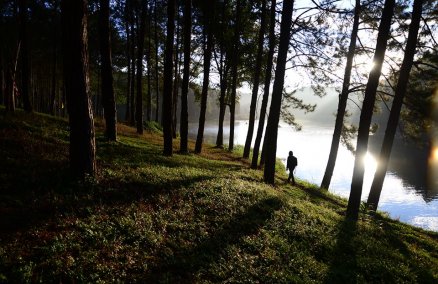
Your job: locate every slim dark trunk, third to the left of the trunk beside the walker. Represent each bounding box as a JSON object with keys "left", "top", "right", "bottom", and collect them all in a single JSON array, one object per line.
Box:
[{"left": 228, "top": 0, "right": 242, "bottom": 151}]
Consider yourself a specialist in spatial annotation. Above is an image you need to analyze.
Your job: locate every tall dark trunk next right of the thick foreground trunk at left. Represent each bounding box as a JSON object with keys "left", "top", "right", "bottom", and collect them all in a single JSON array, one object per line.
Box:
[{"left": 99, "top": 0, "right": 117, "bottom": 141}]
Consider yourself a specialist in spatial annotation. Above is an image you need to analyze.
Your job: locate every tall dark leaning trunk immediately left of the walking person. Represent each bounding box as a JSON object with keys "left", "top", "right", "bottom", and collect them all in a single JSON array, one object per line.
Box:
[{"left": 264, "top": 0, "right": 294, "bottom": 184}]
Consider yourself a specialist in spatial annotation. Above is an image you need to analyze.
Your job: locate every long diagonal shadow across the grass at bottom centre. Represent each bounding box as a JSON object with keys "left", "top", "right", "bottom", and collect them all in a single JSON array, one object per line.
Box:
[{"left": 145, "top": 197, "right": 284, "bottom": 283}]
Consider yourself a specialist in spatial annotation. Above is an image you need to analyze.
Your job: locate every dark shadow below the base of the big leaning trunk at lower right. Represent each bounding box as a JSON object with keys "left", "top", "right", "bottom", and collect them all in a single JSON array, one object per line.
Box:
[{"left": 324, "top": 219, "right": 358, "bottom": 283}]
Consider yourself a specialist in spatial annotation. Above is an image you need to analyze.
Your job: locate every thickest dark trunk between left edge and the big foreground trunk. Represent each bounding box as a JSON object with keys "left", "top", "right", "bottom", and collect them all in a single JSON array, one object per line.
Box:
[{"left": 18, "top": 0, "right": 32, "bottom": 112}]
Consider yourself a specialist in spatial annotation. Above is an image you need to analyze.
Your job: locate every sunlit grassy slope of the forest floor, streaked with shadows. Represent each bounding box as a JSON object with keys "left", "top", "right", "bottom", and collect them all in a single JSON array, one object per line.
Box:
[{"left": 0, "top": 108, "right": 438, "bottom": 283}]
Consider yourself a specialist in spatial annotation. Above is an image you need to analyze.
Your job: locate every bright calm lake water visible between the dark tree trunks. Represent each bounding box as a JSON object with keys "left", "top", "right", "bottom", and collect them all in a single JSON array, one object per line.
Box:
[{"left": 189, "top": 121, "right": 438, "bottom": 231}]
